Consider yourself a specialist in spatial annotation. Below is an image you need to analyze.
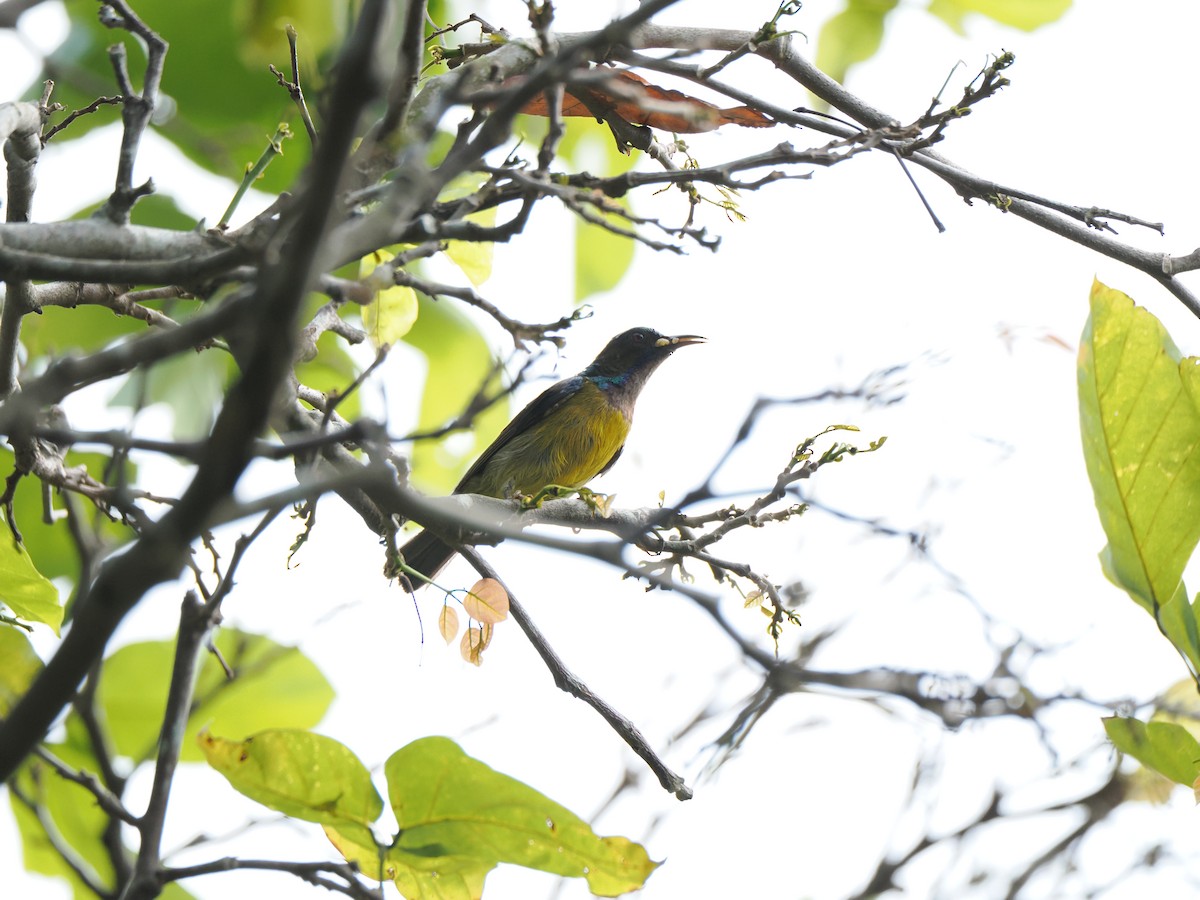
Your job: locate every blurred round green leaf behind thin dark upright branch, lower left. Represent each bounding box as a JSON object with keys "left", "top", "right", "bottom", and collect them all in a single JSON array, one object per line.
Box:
[{"left": 96, "top": 629, "right": 334, "bottom": 762}]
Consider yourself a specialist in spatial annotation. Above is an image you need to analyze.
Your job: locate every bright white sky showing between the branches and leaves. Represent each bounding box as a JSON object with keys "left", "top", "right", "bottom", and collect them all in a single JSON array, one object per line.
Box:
[{"left": 0, "top": 0, "right": 1200, "bottom": 900}]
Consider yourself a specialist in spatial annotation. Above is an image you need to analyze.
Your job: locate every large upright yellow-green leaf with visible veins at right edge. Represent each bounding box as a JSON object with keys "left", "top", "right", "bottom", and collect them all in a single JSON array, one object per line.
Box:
[{"left": 1079, "top": 282, "right": 1200, "bottom": 619}]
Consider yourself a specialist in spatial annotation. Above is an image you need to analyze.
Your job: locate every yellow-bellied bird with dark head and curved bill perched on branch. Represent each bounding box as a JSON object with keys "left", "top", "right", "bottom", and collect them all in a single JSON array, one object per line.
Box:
[{"left": 401, "top": 328, "right": 704, "bottom": 590}]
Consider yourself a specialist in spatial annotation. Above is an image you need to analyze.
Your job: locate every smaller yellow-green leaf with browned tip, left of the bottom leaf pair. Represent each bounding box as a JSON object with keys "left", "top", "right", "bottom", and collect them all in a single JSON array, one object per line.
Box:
[{"left": 199, "top": 730, "right": 383, "bottom": 844}]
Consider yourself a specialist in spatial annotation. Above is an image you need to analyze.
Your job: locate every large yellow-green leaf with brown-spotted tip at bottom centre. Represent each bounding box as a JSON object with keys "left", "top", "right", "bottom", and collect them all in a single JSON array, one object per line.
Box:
[{"left": 384, "top": 738, "right": 658, "bottom": 900}]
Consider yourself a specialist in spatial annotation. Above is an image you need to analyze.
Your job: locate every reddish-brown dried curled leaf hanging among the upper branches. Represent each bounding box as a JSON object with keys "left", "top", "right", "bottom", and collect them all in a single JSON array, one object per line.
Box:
[{"left": 521, "top": 68, "right": 775, "bottom": 134}]
